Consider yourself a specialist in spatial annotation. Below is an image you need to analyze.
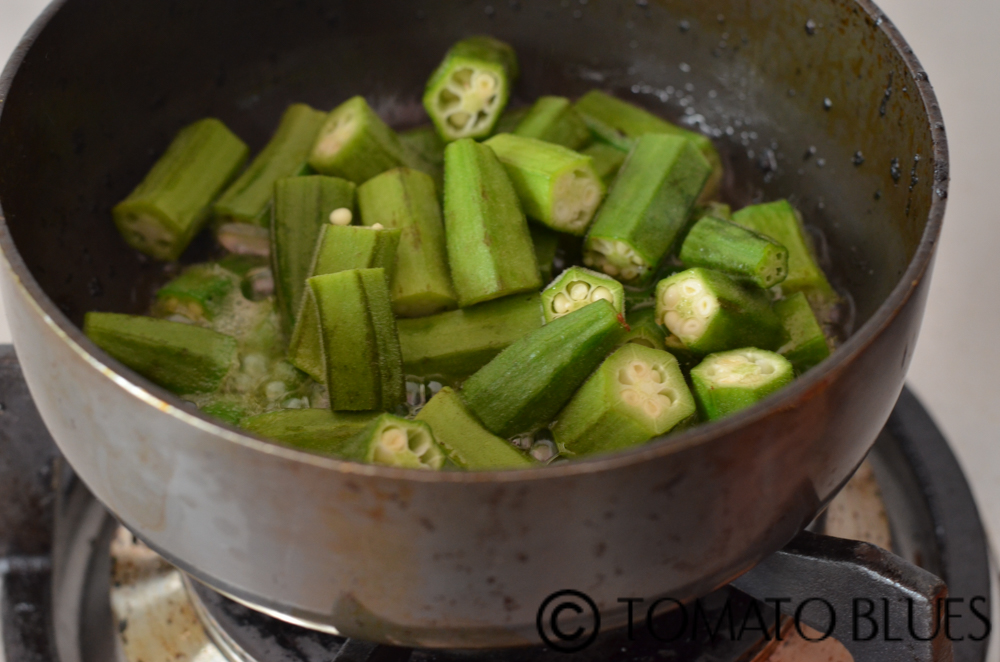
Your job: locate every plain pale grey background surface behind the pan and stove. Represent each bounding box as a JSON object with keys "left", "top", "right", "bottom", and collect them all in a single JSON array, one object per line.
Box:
[{"left": 0, "top": 0, "right": 1000, "bottom": 547}]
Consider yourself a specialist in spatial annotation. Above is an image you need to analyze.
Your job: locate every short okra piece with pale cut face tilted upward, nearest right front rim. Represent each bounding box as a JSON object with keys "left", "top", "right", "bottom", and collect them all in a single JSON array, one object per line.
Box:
[{"left": 691, "top": 347, "right": 795, "bottom": 421}]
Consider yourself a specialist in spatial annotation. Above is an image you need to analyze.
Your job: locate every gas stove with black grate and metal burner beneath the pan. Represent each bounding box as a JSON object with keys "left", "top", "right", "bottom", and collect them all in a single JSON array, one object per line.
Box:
[{"left": 0, "top": 346, "right": 1000, "bottom": 662}]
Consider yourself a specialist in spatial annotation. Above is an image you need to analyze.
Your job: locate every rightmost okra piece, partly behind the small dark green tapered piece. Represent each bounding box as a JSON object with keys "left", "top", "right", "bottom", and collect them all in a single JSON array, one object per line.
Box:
[{"left": 733, "top": 200, "right": 839, "bottom": 309}]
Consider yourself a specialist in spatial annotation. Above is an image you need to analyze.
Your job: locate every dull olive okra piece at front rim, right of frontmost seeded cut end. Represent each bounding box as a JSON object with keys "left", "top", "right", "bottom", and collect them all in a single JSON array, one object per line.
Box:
[{"left": 416, "top": 386, "right": 538, "bottom": 471}]
